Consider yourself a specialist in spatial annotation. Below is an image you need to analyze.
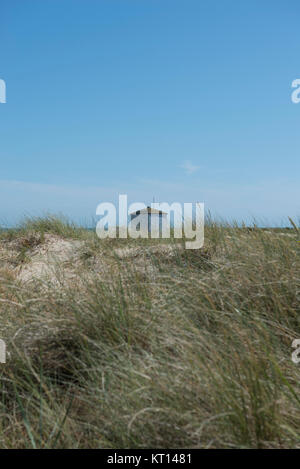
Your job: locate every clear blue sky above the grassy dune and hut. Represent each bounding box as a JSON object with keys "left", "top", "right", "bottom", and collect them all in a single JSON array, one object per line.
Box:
[{"left": 0, "top": 0, "right": 300, "bottom": 223}]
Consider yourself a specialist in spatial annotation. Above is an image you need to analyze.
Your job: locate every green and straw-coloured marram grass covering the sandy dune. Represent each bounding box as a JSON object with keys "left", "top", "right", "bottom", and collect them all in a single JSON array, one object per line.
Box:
[{"left": 0, "top": 216, "right": 300, "bottom": 448}]
